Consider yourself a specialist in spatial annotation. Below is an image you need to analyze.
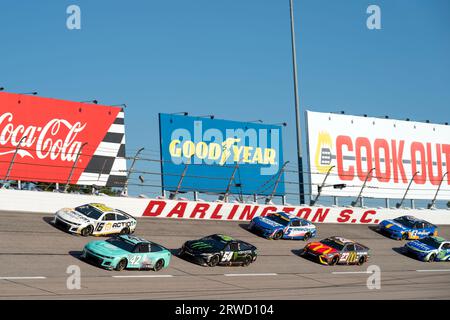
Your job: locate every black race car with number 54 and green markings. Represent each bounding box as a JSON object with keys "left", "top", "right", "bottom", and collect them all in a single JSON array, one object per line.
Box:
[{"left": 179, "top": 234, "right": 258, "bottom": 267}]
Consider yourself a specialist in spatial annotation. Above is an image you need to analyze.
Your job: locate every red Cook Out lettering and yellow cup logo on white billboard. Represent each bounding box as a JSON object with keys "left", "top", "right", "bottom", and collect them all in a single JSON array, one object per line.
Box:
[{"left": 322, "top": 135, "right": 450, "bottom": 185}]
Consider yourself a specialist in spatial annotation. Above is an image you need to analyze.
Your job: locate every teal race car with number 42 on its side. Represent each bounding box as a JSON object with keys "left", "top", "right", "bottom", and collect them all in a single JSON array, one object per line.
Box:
[{"left": 81, "top": 235, "right": 172, "bottom": 271}]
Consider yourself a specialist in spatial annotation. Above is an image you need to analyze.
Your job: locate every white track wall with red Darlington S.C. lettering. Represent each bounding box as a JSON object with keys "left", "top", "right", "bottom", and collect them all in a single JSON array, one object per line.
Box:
[{"left": 0, "top": 189, "right": 450, "bottom": 228}]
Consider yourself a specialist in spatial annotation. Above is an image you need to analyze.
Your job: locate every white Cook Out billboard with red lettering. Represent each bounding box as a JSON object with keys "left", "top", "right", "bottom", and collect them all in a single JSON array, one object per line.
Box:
[{"left": 306, "top": 111, "right": 450, "bottom": 200}]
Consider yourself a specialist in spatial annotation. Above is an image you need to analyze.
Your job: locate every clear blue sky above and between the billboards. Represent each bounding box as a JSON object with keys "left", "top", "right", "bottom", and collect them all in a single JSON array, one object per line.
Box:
[{"left": 0, "top": 0, "right": 450, "bottom": 205}]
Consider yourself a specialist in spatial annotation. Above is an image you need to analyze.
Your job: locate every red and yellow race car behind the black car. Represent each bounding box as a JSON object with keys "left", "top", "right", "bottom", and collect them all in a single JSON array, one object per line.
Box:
[{"left": 301, "top": 237, "right": 369, "bottom": 266}]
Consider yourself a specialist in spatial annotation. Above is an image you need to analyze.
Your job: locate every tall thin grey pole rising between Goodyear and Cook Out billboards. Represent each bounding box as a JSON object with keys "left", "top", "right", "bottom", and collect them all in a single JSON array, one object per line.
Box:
[{"left": 289, "top": 0, "right": 305, "bottom": 204}]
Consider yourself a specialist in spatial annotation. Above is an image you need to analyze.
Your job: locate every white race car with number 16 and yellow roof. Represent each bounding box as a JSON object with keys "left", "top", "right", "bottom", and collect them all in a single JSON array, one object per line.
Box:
[{"left": 53, "top": 203, "right": 137, "bottom": 237}]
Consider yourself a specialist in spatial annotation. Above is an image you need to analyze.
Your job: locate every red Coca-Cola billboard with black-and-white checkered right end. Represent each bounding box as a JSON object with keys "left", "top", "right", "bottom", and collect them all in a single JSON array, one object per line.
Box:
[{"left": 0, "top": 92, "right": 126, "bottom": 187}]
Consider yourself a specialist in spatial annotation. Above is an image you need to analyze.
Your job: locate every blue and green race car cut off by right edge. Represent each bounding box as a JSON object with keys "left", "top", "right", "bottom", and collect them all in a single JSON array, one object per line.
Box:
[{"left": 404, "top": 236, "right": 450, "bottom": 262}]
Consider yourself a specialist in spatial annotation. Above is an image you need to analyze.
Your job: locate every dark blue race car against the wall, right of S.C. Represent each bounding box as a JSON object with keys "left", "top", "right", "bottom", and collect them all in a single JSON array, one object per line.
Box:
[{"left": 378, "top": 216, "right": 437, "bottom": 240}]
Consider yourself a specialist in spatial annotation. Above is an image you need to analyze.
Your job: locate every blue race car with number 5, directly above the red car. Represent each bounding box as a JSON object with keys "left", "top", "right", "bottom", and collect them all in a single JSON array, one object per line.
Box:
[{"left": 249, "top": 212, "right": 317, "bottom": 241}]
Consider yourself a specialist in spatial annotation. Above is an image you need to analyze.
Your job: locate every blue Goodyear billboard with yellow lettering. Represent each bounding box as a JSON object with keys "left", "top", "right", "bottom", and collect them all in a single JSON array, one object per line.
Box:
[{"left": 159, "top": 113, "right": 285, "bottom": 196}]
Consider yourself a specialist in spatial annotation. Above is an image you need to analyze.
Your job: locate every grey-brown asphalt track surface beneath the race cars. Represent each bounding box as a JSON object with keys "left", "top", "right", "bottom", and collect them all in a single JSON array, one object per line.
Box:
[{"left": 0, "top": 212, "right": 450, "bottom": 299}]
